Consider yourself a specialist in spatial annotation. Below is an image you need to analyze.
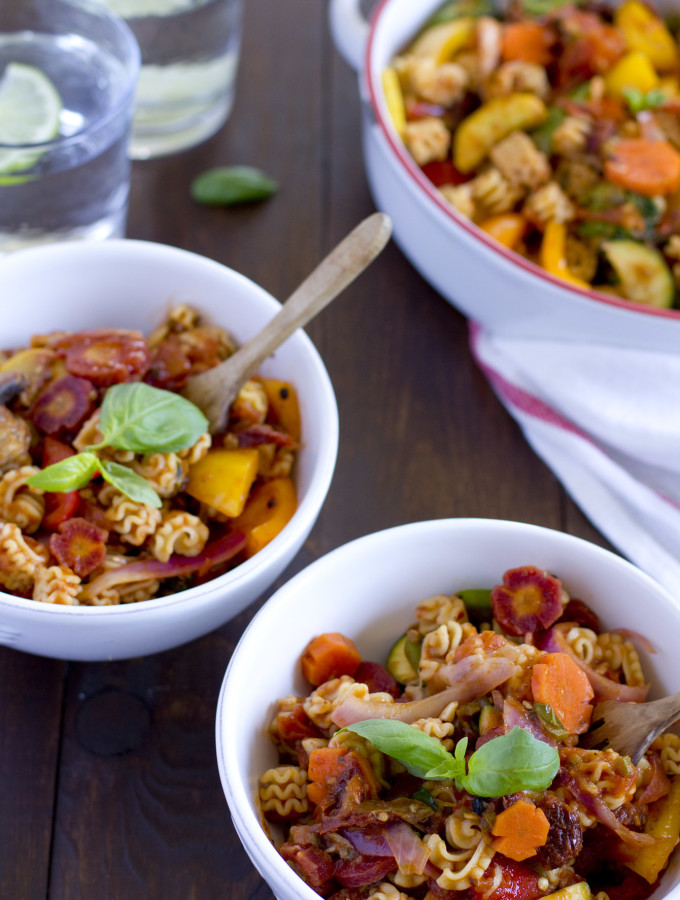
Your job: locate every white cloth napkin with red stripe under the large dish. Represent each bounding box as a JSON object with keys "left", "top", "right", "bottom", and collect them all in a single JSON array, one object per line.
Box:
[{"left": 470, "top": 322, "right": 680, "bottom": 601}]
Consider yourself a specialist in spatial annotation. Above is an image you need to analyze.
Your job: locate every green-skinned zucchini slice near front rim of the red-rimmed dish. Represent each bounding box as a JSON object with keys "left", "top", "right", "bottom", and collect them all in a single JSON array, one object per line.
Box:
[{"left": 602, "top": 241, "right": 675, "bottom": 309}]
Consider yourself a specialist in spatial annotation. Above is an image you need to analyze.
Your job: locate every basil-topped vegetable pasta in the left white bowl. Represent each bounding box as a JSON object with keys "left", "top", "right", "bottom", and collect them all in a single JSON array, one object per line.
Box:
[{"left": 0, "top": 304, "right": 300, "bottom": 606}]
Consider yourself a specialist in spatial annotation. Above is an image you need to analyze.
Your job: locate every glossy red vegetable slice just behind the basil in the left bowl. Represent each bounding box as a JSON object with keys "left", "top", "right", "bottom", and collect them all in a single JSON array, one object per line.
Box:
[{"left": 57, "top": 328, "right": 150, "bottom": 387}]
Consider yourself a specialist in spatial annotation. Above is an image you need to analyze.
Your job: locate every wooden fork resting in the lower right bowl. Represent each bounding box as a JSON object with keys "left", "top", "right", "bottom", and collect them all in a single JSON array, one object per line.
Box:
[{"left": 579, "top": 691, "right": 680, "bottom": 765}]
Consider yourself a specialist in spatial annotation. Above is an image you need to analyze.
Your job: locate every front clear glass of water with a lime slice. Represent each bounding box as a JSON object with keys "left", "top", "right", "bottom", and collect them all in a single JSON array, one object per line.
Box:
[{"left": 0, "top": 0, "right": 140, "bottom": 254}]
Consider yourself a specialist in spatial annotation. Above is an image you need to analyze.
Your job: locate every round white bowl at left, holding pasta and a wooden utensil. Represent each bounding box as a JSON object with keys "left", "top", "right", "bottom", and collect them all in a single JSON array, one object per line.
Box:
[{"left": 0, "top": 240, "right": 338, "bottom": 660}]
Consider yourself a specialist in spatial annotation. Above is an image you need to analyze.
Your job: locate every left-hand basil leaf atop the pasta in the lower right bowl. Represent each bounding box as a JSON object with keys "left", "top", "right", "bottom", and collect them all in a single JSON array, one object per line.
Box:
[{"left": 343, "top": 719, "right": 464, "bottom": 779}]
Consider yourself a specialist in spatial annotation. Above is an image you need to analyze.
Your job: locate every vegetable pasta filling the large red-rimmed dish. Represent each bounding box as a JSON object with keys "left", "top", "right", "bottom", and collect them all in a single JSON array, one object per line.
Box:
[{"left": 383, "top": 0, "right": 680, "bottom": 308}]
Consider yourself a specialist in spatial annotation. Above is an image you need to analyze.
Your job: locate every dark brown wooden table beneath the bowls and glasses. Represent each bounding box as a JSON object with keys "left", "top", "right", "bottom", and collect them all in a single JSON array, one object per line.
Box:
[{"left": 0, "top": 0, "right": 606, "bottom": 900}]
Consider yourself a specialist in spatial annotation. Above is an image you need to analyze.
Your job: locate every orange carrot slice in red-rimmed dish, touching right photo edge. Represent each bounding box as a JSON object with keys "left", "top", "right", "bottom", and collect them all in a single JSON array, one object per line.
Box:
[{"left": 604, "top": 138, "right": 680, "bottom": 197}]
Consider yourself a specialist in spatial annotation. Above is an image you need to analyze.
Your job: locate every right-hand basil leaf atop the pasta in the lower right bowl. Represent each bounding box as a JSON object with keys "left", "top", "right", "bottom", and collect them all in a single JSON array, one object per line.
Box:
[{"left": 456, "top": 727, "right": 560, "bottom": 797}]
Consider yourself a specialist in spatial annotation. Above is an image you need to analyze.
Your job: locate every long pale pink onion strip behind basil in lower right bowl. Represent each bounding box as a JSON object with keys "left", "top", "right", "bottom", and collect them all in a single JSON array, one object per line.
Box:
[{"left": 331, "top": 657, "right": 515, "bottom": 728}]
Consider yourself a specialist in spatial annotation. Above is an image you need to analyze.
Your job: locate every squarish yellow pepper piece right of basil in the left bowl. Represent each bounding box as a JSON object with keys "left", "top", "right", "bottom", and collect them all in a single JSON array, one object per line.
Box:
[{"left": 186, "top": 447, "right": 259, "bottom": 516}]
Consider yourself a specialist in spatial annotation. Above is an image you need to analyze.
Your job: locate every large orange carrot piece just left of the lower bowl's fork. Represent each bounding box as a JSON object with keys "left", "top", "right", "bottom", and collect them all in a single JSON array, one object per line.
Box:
[{"left": 531, "top": 653, "right": 595, "bottom": 734}]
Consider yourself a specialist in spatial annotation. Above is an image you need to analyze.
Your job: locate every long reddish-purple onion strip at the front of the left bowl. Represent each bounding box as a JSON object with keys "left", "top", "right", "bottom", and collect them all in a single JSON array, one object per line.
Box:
[{"left": 82, "top": 531, "right": 246, "bottom": 595}]
